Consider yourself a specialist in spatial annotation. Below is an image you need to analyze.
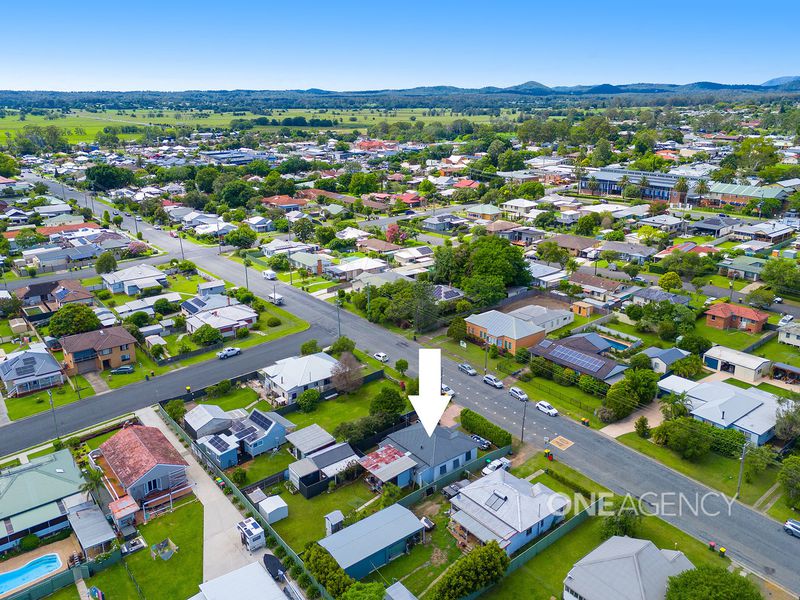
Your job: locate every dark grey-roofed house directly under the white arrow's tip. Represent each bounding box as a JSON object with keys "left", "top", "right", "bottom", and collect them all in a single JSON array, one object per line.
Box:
[{"left": 379, "top": 423, "right": 478, "bottom": 485}]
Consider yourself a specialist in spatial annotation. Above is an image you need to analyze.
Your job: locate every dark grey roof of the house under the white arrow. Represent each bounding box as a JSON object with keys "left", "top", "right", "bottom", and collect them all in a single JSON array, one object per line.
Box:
[{"left": 384, "top": 423, "right": 478, "bottom": 467}]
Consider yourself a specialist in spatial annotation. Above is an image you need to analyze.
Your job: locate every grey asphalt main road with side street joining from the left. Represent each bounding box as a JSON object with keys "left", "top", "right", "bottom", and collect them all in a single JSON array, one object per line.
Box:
[{"left": 14, "top": 173, "right": 800, "bottom": 593}]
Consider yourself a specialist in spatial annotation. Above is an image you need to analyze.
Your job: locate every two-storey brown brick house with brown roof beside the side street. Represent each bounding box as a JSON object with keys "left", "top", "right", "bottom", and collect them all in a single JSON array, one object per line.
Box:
[{"left": 61, "top": 326, "right": 136, "bottom": 375}]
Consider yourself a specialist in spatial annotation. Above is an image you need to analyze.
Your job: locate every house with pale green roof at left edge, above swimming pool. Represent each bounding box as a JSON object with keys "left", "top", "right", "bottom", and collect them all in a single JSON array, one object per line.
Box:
[{"left": 0, "top": 450, "right": 86, "bottom": 552}]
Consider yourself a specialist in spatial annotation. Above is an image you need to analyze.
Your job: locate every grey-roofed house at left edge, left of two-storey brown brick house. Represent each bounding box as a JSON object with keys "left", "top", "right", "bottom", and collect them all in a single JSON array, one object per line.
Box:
[{"left": 0, "top": 343, "right": 64, "bottom": 396}]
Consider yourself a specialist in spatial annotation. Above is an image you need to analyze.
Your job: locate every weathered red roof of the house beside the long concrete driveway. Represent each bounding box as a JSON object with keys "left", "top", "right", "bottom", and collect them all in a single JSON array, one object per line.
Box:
[{"left": 100, "top": 425, "right": 189, "bottom": 488}]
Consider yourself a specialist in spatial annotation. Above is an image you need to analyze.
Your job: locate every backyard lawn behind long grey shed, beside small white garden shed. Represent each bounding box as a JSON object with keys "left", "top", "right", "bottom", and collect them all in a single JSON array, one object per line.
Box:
[{"left": 272, "top": 479, "right": 374, "bottom": 552}]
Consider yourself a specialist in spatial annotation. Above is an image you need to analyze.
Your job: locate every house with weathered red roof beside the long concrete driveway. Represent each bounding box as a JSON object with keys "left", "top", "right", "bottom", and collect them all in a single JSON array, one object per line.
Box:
[{"left": 97, "top": 425, "right": 191, "bottom": 505}]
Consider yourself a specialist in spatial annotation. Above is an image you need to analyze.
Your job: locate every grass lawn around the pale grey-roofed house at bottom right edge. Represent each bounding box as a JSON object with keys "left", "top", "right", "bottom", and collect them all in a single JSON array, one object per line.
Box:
[{"left": 481, "top": 517, "right": 730, "bottom": 600}]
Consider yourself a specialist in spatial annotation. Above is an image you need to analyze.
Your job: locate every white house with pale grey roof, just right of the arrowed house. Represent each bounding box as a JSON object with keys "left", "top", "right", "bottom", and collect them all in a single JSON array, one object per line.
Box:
[{"left": 449, "top": 469, "right": 570, "bottom": 555}]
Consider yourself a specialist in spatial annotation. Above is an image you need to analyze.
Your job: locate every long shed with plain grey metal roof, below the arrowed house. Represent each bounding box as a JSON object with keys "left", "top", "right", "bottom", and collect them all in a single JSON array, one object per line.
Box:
[{"left": 319, "top": 504, "right": 423, "bottom": 579}]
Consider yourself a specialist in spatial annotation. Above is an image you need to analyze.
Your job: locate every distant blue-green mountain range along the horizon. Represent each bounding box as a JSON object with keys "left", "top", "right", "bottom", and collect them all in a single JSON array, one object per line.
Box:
[{"left": 0, "top": 76, "right": 800, "bottom": 111}]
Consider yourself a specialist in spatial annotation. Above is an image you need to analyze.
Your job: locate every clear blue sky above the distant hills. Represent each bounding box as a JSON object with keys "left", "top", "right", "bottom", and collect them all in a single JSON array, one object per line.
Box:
[{"left": 6, "top": 0, "right": 800, "bottom": 90}]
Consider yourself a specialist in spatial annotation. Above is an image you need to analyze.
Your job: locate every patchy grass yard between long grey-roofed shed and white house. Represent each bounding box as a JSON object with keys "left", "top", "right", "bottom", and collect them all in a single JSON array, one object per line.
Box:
[{"left": 365, "top": 494, "right": 462, "bottom": 597}]
